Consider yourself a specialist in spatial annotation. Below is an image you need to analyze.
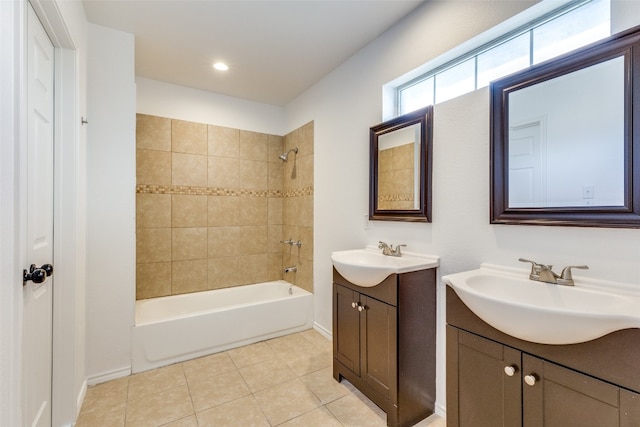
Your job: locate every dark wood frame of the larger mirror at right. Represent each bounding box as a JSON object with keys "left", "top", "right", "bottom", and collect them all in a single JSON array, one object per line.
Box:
[{"left": 490, "top": 27, "right": 640, "bottom": 228}]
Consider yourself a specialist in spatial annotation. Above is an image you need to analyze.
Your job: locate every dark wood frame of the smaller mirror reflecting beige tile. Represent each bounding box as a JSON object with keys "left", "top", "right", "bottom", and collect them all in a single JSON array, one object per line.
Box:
[{"left": 369, "top": 105, "right": 433, "bottom": 222}]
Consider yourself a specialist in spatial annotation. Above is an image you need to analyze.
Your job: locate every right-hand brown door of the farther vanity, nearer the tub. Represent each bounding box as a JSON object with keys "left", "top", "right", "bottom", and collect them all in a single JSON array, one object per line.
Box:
[{"left": 360, "top": 295, "right": 398, "bottom": 403}]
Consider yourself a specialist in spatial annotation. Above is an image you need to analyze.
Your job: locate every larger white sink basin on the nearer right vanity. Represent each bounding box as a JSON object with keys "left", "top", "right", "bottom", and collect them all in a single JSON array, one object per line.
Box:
[{"left": 442, "top": 264, "right": 640, "bottom": 344}]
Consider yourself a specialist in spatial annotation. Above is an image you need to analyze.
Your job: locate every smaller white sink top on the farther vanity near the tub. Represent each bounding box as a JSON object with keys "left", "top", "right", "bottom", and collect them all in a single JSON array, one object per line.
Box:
[{"left": 331, "top": 246, "right": 438, "bottom": 288}]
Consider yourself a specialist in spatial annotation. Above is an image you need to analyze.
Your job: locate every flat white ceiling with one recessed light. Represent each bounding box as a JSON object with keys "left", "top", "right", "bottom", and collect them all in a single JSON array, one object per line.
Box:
[{"left": 83, "top": 0, "right": 424, "bottom": 106}]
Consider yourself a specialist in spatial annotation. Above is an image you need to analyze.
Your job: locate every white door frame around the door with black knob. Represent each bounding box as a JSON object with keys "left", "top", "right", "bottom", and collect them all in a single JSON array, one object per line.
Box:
[{"left": 0, "top": 0, "right": 86, "bottom": 425}]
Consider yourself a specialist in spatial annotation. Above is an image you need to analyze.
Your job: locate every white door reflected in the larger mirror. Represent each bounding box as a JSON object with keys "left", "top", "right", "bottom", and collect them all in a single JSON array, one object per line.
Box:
[{"left": 509, "top": 118, "right": 547, "bottom": 208}]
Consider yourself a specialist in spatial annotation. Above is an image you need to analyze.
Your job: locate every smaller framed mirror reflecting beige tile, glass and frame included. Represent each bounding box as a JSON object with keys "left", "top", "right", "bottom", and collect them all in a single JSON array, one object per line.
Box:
[{"left": 369, "top": 106, "right": 433, "bottom": 222}]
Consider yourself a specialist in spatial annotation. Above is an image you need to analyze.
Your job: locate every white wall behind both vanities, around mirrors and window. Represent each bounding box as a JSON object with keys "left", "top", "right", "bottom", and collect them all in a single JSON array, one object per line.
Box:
[{"left": 286, "top": 1, "right": 640, "bottom": 412}]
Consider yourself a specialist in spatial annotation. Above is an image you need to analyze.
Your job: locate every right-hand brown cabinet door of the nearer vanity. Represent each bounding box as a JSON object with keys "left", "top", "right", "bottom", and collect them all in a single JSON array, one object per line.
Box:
[{"left": 522, "top": 354, "right": 624, "bottom": 427}]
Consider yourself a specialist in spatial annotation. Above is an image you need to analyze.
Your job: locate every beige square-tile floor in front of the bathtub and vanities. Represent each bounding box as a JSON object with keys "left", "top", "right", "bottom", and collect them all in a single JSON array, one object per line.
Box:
[{"left": 76, "top": 329, "right": 445, "bottom": 427}]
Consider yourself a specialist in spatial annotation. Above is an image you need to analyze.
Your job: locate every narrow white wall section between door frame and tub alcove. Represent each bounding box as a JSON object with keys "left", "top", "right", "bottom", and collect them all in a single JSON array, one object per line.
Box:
[{"left": 86, "top": 24, "right": 136, "bottom": 384}]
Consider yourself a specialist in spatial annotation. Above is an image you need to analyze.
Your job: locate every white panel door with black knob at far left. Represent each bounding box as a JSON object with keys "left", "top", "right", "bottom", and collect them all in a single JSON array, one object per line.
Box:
[{"left": 22, "top": 5, "right": 54, "bottom": 426}]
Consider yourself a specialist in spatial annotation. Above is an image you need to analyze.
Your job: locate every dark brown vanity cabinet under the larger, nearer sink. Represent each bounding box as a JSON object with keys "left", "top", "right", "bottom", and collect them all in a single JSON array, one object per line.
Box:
[{"left": 447, "top": 288, "right": 640, "bottom": 427}]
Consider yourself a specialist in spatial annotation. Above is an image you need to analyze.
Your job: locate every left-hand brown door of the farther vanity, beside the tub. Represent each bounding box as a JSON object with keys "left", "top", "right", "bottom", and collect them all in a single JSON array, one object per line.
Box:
[{"left": 333, "top": 284, "right": 360, "bottom": 375}]
